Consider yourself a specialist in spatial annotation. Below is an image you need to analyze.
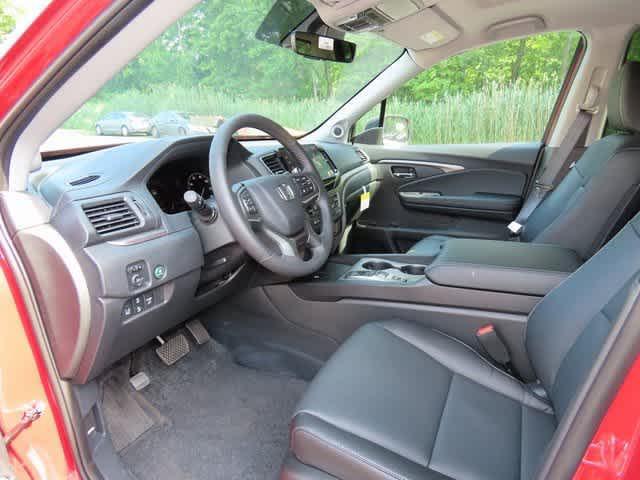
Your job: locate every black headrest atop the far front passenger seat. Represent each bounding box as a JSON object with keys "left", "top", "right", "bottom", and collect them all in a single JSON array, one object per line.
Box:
[{"left": 609, "top": 62, "right": 640, "bottom": 133}]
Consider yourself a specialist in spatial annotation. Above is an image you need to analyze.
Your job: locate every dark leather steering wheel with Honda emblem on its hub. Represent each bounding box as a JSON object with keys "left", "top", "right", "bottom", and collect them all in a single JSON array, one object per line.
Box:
[{"left": 209, "top": 114, "right": 333, "bottom": 277}]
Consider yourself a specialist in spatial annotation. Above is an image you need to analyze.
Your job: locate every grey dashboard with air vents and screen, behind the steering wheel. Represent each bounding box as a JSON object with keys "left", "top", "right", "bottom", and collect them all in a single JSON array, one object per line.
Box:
[{"left": 27, "top": 136, "right": 378, "bottom": 383}]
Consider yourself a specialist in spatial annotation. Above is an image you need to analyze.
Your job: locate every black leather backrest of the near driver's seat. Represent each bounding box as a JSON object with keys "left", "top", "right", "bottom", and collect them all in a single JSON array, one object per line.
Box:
[{"left": 526, "top": 210, "right": 640, "bottom": 418}]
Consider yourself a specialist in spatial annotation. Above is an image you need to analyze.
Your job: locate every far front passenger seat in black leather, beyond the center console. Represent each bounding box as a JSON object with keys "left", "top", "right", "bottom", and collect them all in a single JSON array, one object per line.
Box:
[{"left": 407, "top": 62, "right": 640, "bottom": 258}]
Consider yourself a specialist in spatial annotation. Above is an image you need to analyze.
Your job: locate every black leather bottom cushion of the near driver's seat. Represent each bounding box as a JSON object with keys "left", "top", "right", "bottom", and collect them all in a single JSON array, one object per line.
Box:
[{"left": 291, "top": 321, "right": 556, "bottom": 480}]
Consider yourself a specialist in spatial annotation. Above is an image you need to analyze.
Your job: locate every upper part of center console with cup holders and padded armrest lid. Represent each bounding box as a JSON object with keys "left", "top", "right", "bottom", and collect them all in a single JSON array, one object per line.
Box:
[{"left": 290, "top": 239, "right": 582, "bottom": 315}]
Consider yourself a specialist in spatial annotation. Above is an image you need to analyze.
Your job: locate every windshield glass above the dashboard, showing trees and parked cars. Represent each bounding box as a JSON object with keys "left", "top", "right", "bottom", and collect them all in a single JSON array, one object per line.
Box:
[{"left": 43, "top": 0, "right": 402, "bottom": 151}]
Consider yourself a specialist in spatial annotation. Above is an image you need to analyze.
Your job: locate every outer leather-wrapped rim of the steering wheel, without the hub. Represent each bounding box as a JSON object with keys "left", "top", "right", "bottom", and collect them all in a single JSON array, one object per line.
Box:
[{"left": 209, "top": 114, "right": 333, "bottom": 277}]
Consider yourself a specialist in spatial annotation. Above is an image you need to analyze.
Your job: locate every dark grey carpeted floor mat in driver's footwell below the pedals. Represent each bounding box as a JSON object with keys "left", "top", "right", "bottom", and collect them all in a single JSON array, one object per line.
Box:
[{"left": 121, "top": 341, "right": 306, "bottom": 480}]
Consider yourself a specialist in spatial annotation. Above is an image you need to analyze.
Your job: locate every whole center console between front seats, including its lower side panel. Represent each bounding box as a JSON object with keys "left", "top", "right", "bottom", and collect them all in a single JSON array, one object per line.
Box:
[{"left": 263, "top": 239, "right": 582, "bottom": 379}]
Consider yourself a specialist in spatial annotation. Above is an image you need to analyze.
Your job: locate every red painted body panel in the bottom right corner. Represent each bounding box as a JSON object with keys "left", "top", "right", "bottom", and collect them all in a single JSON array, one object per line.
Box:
[{"left": 573, "top": 356, "right": 640, "bottom": 480}]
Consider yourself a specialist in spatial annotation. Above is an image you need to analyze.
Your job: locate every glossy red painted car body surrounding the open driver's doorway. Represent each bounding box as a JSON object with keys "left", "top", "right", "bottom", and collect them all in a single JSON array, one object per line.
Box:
[{"left": 0, "top": 0, "right": 640, "bottom": 480}]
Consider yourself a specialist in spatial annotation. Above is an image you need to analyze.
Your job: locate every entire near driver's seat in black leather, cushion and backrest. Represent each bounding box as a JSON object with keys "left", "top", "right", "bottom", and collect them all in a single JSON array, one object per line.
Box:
[{"left": 281, "top": 212, "right": 640, "bottom": 480}]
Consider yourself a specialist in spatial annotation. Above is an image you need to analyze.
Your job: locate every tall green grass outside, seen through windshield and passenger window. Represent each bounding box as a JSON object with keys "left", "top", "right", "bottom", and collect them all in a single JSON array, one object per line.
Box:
[{"left": 64, "top": 83, "right": 558, "bottom": 144}]
